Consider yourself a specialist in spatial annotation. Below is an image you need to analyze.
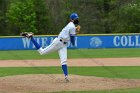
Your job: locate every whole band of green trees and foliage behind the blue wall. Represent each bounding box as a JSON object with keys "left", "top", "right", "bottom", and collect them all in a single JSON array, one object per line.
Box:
[{"left": 0, "top": 0, "right": 140, "bottom": 35}]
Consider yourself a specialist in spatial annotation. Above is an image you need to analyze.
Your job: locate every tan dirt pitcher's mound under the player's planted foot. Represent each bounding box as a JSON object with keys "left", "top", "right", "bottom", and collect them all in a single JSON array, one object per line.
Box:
[{"left": 0, "top": 74, "right": 140, "bottom": 93}]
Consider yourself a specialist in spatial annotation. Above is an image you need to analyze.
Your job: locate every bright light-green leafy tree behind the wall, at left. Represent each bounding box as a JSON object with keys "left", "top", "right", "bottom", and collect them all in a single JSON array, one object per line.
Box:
[{"left": 6, "top": 0, "right": 37, "bottom": 34}]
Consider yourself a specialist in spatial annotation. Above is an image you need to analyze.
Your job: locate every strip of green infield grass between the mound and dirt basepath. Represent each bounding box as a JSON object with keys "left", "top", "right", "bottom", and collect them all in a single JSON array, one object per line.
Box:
[{"left": 0, "top": 66, "right": 140, "bottom": 79}]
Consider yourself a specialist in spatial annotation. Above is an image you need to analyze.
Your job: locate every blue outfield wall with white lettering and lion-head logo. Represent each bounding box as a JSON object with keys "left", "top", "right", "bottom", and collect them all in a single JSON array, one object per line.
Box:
[{"left": 0, "top": 34, "right": 140, "bottom": 50}]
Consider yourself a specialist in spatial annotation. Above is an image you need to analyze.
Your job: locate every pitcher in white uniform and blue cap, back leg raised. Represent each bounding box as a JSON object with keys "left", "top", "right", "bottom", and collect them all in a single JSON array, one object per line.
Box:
[{"left": 20, "top": 13, "right": 80, "bottom": 82}]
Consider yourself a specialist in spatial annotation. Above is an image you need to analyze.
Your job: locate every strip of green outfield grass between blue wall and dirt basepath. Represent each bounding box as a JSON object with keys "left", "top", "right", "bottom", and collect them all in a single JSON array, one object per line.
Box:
[{"left": 0, "top": 48, "right": 140, "bottom": 60}]
